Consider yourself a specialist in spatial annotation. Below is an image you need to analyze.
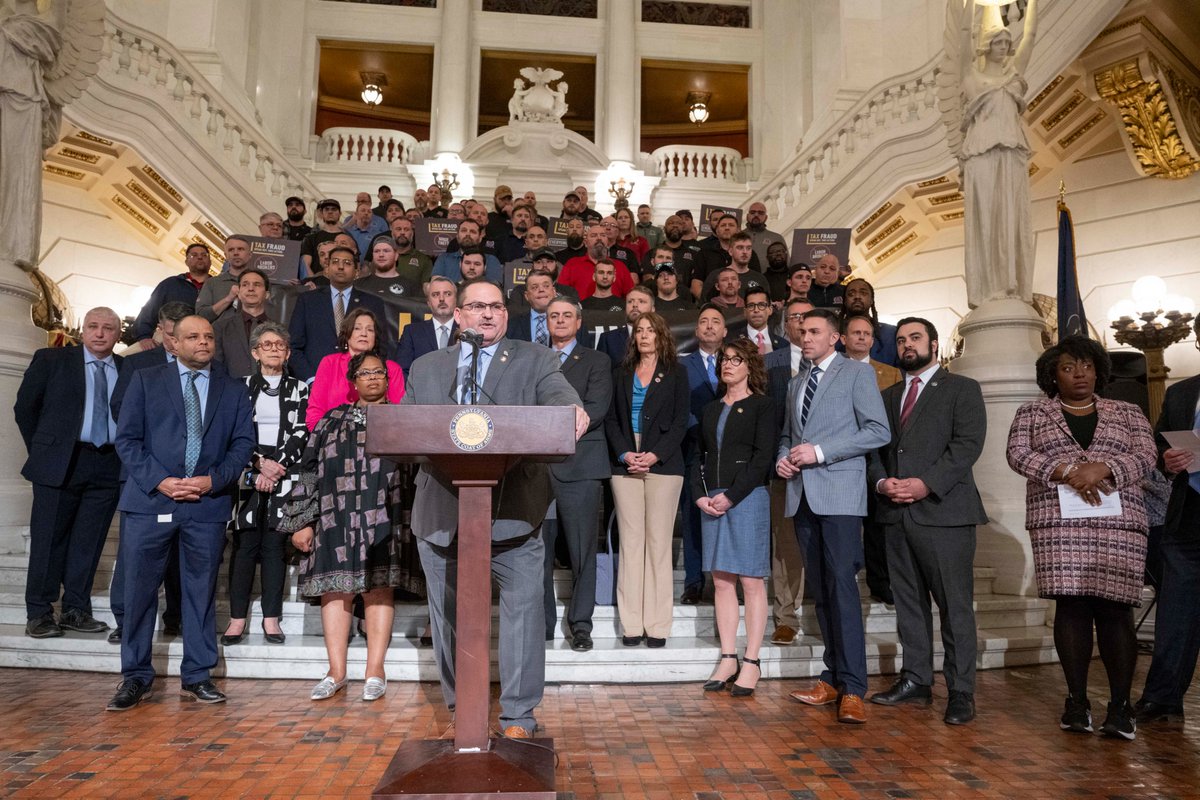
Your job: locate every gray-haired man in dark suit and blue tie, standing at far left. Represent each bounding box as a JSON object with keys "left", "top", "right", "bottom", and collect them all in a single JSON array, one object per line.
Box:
[{"left": 13, "top": 308, "right": 121, "bottom": 639}]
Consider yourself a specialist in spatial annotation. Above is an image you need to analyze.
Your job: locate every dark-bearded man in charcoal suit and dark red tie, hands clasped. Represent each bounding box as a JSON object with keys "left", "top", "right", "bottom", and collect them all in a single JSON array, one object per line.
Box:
[{"left": 869, "top": 317, "right": 988, "bottom": 724}]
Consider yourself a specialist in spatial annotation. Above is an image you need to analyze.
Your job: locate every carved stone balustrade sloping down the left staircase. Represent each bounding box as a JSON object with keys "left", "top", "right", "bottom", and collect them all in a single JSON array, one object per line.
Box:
[{"left": 67, "top": 11, "right": 320, "bottom": 229}]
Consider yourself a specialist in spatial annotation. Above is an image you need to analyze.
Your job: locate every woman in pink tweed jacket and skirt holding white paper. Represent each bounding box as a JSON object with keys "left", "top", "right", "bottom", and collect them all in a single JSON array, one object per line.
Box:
[{"left": 1008, "top": 336, "right": 1157, "bottom": 740}]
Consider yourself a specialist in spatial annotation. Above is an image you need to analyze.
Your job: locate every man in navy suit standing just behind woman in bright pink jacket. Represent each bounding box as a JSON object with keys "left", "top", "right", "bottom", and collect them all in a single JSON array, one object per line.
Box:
[{"left": 288, "top": 247, "right": 394, "bottom": 381}]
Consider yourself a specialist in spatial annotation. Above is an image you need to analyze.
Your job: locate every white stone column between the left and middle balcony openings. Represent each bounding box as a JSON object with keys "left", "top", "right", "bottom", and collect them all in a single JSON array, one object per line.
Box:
[{"left": 430, "top": 2, "right": 478, "bottom": 155}]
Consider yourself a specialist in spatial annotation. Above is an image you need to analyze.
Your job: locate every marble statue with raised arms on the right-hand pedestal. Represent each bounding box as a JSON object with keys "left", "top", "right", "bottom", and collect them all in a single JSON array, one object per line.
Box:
[{"left": 938, "top": 0, "right": 1037, "bottom": 308}]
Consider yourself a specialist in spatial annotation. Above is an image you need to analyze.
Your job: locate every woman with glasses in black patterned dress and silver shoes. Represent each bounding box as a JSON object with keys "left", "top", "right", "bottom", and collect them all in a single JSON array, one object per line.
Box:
[{"left": 280, "top": 353, "right": 404, "bottom": 702}]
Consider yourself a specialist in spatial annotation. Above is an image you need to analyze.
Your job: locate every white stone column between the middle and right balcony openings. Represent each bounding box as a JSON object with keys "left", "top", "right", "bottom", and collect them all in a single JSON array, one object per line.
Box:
[{"left": 596, "top": 1, "right": 638, "bottom": 166}]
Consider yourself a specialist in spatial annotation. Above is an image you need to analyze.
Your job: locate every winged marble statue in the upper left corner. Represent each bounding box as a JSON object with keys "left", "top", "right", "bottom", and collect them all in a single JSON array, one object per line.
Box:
[{"left": 0, "top": 0, "right": 104, "bottom": 271}]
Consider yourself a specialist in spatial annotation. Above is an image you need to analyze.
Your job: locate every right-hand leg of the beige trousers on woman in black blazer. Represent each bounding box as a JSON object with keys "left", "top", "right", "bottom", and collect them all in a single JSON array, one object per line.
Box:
[{"left": 642, "top": 474, "right": 683, "bottom": 639}]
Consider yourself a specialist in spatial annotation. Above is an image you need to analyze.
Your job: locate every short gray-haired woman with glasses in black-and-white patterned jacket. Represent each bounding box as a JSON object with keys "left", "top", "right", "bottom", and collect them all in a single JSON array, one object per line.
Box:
[{"left": 221, "top": 321, "right": 308, "bottom": 645}]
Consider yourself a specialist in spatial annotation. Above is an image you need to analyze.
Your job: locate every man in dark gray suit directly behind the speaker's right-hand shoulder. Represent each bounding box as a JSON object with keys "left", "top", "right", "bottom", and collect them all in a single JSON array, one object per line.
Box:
[{"left": 545, "top": 295, "right": 612, "bottom": 652}]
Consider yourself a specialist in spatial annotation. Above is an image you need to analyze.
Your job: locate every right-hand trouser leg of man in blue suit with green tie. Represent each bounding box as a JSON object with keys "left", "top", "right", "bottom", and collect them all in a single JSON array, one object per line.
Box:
[{"left": 179, "top": 521, "right": 226, "bottom": 684}]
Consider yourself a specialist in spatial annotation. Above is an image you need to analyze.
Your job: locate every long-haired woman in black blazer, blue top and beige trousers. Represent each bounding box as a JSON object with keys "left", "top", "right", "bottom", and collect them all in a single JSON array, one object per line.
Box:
[{"left": 605, "top": 312, "right": 690, "bottom": 648}]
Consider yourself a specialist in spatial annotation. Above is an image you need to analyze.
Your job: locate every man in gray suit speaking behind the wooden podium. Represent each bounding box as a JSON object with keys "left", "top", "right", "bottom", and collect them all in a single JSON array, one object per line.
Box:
[{"left": 402, "top": 281, "right": 590, "bottom": 739}]
